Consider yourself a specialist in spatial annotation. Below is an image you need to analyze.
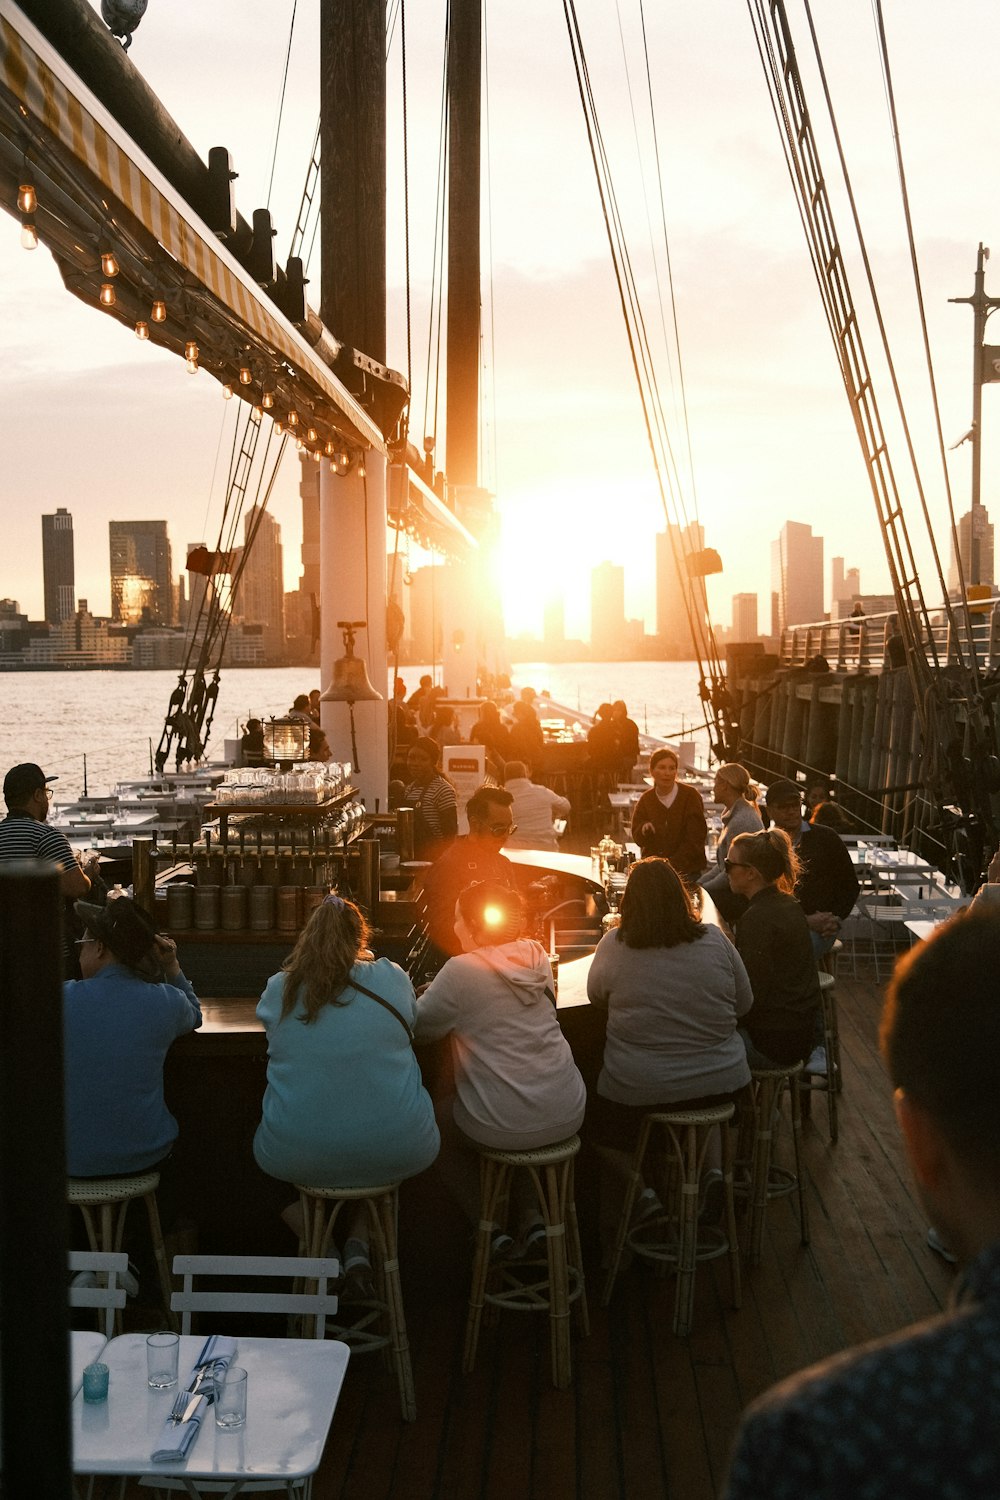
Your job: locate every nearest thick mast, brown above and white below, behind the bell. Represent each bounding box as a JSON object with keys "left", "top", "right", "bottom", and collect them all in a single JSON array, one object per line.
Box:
[{"left": 319, "top": 0, "right": 388, "bottom": 812}]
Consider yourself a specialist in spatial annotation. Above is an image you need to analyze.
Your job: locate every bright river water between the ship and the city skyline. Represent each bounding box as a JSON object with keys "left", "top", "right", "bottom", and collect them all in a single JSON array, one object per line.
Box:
[{"left": 0, "top": 662, "right": 705, "bottom": 801}]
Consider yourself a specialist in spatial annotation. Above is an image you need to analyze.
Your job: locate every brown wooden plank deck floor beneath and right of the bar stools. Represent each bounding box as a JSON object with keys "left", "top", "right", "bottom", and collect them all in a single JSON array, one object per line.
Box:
[{"left": 301, "top": 960, "right": 951, "bottom": 1500}]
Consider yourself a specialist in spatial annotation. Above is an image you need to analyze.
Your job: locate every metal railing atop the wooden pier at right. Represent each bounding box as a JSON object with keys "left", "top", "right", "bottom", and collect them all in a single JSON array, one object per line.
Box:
[{"left": 778, "top": 594, "right": 1000, "bottom": 672}]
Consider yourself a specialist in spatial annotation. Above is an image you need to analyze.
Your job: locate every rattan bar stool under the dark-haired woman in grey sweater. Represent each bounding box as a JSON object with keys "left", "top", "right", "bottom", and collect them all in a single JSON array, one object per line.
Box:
[{"left": 604, "top": 1104, "right": 742, "bottom": 1338}]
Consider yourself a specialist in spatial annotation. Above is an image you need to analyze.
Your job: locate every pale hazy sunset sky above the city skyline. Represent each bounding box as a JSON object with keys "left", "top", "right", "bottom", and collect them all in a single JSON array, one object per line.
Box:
[{"left": 0, "top": 0, "right": 1000, "bottom": 636}]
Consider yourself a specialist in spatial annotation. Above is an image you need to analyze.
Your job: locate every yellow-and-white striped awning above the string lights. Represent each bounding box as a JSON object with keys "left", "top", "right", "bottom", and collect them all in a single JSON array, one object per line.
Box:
[{"left": 0, "top": 0, "right": 385, "bottom": 453}]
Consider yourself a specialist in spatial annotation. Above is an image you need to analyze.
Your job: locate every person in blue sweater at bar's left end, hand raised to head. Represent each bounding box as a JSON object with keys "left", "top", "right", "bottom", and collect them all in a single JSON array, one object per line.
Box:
[{"left": 63, "top": 896, "right": 201, "bottom": 1223}]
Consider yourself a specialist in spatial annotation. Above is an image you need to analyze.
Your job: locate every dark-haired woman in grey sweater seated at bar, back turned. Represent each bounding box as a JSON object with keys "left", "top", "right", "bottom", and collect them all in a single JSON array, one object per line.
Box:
[{"left": 586, "top": 857, "right": 753, "bottom": 1230}]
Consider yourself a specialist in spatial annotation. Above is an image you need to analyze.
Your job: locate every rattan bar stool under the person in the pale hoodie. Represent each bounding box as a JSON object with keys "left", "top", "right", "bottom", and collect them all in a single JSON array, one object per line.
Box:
[{"left": 462, "top": 1136, "right": 591, "bottom": 1389}]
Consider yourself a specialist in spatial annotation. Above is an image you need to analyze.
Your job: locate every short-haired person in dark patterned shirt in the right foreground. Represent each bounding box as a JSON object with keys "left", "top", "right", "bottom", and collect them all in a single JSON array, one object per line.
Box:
[{"left": 724, "top": 909, "right": 1000, "bottom": 1500}]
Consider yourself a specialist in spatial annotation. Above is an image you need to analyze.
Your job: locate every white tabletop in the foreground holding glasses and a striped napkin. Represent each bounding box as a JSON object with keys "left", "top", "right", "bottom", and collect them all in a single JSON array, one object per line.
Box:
[{"left": 72, "top": 1334, "right": 349, "bottom": 1481}]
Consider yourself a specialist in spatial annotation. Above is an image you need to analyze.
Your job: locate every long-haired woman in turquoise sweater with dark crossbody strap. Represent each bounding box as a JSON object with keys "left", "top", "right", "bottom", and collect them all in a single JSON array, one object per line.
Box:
[{"left": 253, "top": 896, "right": 439, "bottom": 1292}]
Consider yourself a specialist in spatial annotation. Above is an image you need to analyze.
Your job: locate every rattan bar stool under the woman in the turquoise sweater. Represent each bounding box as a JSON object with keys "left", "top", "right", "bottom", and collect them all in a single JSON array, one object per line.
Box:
[{"left": 295, "top": 1182, "right": 417, "bottom": 1422}]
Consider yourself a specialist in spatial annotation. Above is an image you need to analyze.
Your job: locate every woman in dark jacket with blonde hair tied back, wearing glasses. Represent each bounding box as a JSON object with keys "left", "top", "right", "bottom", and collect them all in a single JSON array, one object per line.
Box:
[{"left": 726, "top": 828, "right": 820, "bottom": 1068}]
